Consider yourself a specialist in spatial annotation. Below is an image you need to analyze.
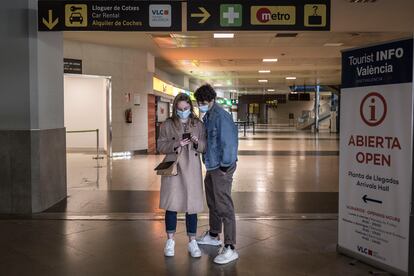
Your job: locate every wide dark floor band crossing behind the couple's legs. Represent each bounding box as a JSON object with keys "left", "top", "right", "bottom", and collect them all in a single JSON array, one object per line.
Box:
[{"left": 39, "top": 190, "right": 338, "bottom": 217}]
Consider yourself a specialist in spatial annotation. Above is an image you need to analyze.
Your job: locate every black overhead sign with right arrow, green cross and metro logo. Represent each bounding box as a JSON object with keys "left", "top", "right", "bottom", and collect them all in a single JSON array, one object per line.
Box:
[{"left": 187, "top": 0, "right": 330, "bottom": 31}]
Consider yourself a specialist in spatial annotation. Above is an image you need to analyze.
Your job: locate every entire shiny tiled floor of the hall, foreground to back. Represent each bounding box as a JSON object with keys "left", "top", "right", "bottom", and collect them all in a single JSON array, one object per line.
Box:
[{"left": 0, "top": 128, "right": 385, "bottom": 276}]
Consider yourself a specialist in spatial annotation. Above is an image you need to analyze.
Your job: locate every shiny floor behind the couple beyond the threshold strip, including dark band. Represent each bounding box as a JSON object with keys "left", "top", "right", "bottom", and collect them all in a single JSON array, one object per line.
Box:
[{"left": 58, "top": 128, "right": 339, "bottom": 215}]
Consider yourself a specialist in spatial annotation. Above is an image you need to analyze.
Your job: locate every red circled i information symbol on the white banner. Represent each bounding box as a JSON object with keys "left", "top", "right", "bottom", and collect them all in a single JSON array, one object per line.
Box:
[{"left": 359, "top": 92, "right": 387, "bottom": 127}]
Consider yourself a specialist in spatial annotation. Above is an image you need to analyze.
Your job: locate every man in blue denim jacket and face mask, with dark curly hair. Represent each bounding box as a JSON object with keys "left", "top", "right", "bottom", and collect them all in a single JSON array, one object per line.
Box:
[{"left": 194, "top": 84, "right": 239, "bottom": 264}]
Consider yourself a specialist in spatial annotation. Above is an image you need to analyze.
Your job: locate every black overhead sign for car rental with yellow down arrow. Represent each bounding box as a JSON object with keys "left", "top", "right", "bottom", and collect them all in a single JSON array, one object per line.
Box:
[{"left": 38, "top": 1, "right": 182, "bottom": 32}]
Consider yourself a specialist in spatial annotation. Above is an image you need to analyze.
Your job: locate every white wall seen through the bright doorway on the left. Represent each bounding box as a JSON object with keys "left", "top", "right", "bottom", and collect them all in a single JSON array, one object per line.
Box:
[{"left": 64, "top": 76, "right": 107, "bottom": 150}]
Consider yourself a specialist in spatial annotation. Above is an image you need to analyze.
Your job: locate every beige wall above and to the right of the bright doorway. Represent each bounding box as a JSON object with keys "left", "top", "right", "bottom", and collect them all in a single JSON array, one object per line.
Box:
[{"left": 64, "top": 40, "right": 154, "bottom": 152}]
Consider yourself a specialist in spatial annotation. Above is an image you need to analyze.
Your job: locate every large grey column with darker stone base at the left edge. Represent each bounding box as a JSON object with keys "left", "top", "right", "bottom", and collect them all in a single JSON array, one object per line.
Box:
[{"left": 0, "top": 0, "right": 66, "bottom": 214}]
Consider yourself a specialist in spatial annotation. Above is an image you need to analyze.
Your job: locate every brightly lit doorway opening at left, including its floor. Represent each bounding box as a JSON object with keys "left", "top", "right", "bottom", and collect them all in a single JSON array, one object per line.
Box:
[{"left": 64, "top": 74, "right": 112, "bottom": 191}]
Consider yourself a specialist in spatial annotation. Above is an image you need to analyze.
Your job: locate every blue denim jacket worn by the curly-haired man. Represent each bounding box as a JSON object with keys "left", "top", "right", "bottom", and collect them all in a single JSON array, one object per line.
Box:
[{"left": 203, "top": 103, "right": 239, "bottom": 171}]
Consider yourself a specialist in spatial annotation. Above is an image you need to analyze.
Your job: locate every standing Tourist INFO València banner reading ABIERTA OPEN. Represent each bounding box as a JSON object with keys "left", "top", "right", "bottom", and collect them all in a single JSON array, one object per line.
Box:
[{"left": 338, "top": 39, "right": 413, "bottom": 274}]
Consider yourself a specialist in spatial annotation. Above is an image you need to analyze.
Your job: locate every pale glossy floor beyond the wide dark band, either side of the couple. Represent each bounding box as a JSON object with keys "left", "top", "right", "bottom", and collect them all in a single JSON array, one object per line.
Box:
[{"left": 67, "top": 133, "right": 339, "bottom": 194}]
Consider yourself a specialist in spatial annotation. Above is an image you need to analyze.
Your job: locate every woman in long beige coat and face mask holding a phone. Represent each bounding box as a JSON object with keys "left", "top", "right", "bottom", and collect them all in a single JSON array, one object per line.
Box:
[{"left": 158, "top": 93, "right": 206, "bottom": 258}]
